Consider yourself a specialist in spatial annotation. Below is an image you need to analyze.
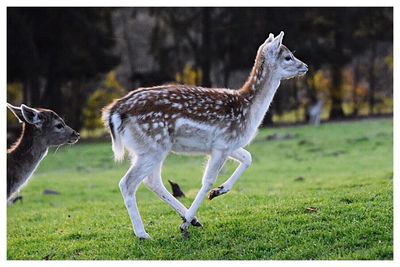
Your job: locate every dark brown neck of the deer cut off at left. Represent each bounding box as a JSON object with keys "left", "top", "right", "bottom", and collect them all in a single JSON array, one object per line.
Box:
[{"left": 7, "top": 123, "right": 48, "bottom": 195}]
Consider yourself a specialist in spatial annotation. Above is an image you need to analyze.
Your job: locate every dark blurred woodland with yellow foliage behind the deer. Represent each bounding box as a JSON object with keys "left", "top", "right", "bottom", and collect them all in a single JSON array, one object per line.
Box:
[{"left": 7, "top": 7, "right": 393, "bottom": 134}]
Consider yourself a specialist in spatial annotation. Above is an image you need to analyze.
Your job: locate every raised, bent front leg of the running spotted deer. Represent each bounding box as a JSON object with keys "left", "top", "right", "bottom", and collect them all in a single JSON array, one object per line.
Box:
[{"left": 208, "top": 148, "right": 251, "bottom": 200}]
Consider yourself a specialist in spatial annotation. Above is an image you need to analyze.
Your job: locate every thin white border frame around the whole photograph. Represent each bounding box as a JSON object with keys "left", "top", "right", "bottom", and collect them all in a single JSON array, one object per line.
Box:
[{"left": 0, "top": 0, "right": 400, "bottom": 267}]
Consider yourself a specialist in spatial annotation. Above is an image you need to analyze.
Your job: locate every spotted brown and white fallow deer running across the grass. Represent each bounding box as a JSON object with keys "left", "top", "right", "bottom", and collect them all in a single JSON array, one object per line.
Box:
[{"left": 103, "top": 32, "right": 308, "bottom": 239}]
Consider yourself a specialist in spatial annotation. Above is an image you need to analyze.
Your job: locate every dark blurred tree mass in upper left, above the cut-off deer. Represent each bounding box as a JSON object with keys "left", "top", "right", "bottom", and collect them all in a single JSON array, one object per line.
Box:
[{"left": 7, "top": 7, "right": 118, "bottom": 129}]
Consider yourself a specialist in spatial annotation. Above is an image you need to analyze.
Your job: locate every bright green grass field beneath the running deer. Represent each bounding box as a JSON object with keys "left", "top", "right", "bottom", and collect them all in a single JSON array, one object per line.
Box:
[{"left": 7, "top": 119, "right": 393, "bottom": 260}]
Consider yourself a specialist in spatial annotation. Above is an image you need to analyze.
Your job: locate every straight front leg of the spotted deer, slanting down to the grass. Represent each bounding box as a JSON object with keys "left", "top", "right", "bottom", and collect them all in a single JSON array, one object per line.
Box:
[{"left": 180, "top": 150, "right": 227, "bottom": 239}]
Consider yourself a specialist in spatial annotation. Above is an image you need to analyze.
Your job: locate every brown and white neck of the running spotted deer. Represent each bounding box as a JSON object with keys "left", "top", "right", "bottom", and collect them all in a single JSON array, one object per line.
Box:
[{"left": 239, "top": 52, "right": 280, "bottom": 128}]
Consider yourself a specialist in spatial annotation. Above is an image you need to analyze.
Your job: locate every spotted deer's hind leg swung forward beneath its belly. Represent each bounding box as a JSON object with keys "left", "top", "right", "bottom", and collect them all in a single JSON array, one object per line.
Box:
[{"left": 143, "top": 162, "right": 202, "bottom": 226}]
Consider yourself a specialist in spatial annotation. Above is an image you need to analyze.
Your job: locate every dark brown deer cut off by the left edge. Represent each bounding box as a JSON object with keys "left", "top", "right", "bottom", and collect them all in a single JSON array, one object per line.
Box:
[{"left": 7, "top": 103, "right": 79, "bottom": 201}]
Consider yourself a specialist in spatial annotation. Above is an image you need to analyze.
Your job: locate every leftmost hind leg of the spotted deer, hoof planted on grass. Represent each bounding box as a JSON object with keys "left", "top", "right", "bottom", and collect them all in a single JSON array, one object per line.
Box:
[{"left": 119, "top": 154, "right": 161, "bottom": 242}]
